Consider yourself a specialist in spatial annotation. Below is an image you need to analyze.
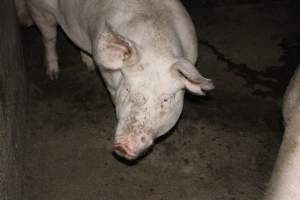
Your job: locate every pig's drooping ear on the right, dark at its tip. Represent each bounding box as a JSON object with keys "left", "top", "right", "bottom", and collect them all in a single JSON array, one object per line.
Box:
[{"left": 173, "top": 60, "right": 214, "bottom": 95}]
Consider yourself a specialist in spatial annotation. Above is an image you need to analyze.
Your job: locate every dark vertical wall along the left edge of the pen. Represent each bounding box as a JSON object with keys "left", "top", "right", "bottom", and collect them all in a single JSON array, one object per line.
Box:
[{"left": 0, "top": 0, "right": 27, "bottom": 200}]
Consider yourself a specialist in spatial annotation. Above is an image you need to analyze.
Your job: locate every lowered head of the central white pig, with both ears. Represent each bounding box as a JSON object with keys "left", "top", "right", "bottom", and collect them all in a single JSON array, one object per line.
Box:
[{"left": 94, "top": 28, "right": 214, "bottom": 160}]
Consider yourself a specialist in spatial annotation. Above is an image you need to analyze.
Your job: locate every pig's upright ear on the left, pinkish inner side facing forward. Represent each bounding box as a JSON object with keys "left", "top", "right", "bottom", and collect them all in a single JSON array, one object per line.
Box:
[{"left": 93, "top": 31, "right": 136, "bottom": 70}]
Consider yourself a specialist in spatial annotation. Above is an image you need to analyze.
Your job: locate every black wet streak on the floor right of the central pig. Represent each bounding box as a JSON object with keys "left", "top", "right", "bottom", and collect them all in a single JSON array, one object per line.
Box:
[{"left": 199, "top": 33, "right": 300, "bottom": 99}]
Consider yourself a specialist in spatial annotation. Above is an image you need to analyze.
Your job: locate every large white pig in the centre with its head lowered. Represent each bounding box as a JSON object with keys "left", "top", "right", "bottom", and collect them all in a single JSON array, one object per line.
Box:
[{"left": 20, "top": 0, "right": 214, "bottom": 159}]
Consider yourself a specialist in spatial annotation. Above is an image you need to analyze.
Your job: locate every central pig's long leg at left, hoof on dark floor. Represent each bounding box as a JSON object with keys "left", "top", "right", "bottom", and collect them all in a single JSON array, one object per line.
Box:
[{"left": 30, "top": 7, "right": 59, "bottom": 80}]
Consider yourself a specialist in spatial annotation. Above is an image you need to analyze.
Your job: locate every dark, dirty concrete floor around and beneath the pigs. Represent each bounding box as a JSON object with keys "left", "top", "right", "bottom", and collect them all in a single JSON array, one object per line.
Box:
[{"left": 22, "top": 1, "right": 300, "bottom": 200}]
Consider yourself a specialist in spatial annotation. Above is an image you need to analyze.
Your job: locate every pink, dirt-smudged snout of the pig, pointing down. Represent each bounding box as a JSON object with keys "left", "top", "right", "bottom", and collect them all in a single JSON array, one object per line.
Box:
[{"left": 112, "top": 136, "right": 153, "bottom": 160}]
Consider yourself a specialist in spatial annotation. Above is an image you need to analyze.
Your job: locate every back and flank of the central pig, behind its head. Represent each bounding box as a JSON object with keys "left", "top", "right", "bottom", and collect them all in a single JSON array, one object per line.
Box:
[{"left": 28, "top": 0, "right": 197, "bottom": 59}]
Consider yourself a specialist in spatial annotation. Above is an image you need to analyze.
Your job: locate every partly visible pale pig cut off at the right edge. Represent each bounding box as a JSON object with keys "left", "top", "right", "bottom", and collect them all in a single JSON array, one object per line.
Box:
[{"left": 265, "top": 68, "right": 300, "bottom": 200}]
